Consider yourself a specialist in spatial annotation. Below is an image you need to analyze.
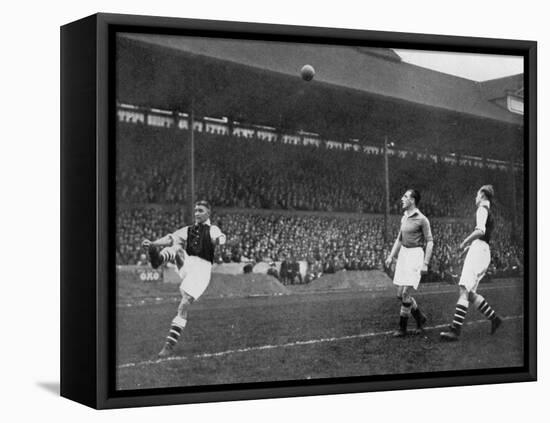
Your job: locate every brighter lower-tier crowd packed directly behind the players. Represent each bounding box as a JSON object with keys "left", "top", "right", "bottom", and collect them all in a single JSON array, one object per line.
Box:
[{"left": 117, "top": 207, "right": 523, "bottom": 281}]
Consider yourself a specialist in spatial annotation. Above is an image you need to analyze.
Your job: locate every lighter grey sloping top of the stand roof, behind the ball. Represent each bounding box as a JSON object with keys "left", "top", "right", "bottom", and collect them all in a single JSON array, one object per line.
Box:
[{"left": 124, "top": 34, "right": 523, "bottom": 125}]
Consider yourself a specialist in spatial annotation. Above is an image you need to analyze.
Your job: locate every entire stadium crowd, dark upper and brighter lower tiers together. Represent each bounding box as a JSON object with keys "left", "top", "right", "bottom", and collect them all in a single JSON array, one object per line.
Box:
[{"left": 116, "top": 124, "right": 523, "bottom": 281}]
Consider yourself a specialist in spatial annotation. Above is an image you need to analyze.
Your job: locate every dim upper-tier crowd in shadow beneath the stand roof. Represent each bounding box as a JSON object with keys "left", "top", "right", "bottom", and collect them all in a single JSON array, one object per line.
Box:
[{"left": 117, "top": 124, "right": 523, "bottom": 217}]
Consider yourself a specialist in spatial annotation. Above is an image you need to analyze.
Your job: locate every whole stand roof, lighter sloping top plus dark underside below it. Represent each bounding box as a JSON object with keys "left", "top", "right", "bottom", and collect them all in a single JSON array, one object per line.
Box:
[{"left": 116, "top": 36, "right": 523, "bottom": 160}]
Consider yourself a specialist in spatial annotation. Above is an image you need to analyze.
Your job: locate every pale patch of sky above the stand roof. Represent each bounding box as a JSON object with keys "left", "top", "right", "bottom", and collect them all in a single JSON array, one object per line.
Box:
[{"left": 394, "top": 49, "right": 523, "bottom": 81}]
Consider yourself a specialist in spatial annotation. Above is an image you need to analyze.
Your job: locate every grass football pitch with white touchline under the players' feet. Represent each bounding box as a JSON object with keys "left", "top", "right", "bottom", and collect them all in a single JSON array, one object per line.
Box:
[{"left": 117, "top": 280, "right": 523, "bottom": 389}]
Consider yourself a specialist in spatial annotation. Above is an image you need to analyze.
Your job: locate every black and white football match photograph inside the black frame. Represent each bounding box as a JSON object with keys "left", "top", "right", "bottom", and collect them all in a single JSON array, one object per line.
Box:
[{"left": 115, "top": 31, "right": 529, "bottom": 391}]
